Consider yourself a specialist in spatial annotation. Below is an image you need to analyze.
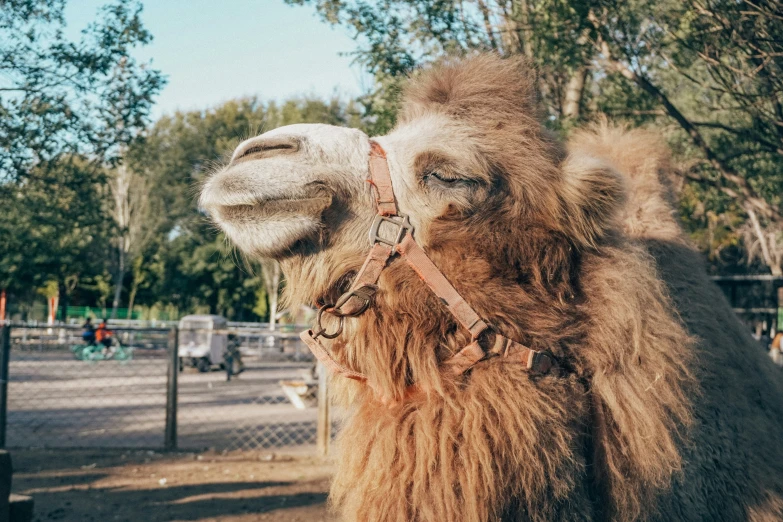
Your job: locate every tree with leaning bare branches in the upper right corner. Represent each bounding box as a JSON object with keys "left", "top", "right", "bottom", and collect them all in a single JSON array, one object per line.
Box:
[{"left": 589, "top": 0, "right": 783, "bottom": 275}]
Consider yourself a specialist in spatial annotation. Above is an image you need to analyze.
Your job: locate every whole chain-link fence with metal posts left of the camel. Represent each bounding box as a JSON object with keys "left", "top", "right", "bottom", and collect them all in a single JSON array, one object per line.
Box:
[{"left": 0, "top": 324, "right": 331, "bottom": 451}]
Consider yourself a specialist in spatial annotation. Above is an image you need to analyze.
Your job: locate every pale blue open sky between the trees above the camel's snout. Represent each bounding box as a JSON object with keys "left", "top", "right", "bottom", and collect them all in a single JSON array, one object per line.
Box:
[{"left": 66, "top": 0, "right": 371, "bottom": 118}]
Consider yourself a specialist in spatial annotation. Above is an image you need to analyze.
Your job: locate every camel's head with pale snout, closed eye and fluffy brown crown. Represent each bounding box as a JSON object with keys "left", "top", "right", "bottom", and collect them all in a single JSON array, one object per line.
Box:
[{"left": 201, "top": 55, "right": 621, "bottom": 308}]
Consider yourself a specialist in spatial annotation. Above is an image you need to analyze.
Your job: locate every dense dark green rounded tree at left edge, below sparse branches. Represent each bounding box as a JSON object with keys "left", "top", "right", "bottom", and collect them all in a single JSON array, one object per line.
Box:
[{"left": 0, "top": 157, "right": 110, "bottom": 318}]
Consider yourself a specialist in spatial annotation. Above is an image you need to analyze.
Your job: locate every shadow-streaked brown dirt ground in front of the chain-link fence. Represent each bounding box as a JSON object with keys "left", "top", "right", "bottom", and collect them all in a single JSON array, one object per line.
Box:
[{"left": 11, "top": 450, "right": 336, "bottom": 522}]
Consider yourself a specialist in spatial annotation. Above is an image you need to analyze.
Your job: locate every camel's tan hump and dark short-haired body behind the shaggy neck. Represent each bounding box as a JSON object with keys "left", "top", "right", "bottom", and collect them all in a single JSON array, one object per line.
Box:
[{"left": 572, "top": 126, "right": 783, "bottom": 520}]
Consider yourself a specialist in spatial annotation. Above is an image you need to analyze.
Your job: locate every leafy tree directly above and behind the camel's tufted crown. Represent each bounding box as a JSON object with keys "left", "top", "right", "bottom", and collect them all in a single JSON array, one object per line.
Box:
[{"left": 285, "top": 0, "right": 594, "bottom": 127}]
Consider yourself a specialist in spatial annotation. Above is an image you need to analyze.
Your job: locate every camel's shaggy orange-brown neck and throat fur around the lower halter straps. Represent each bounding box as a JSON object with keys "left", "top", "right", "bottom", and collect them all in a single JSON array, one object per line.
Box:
[{"left": 318, "top": 230, "right": 592, "bottom": 520}]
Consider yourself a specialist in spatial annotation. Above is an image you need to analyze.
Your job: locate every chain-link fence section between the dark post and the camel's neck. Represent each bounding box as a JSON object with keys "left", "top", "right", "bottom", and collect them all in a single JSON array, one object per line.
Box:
[{"left": 178, "top": 327, "right": 317, "bottom": 450}]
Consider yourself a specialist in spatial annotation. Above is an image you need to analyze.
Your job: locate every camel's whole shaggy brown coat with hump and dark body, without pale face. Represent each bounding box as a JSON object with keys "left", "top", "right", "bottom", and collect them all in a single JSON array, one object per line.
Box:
[{"left": 248, "top": 55, "right": 783, "bottom": 521}]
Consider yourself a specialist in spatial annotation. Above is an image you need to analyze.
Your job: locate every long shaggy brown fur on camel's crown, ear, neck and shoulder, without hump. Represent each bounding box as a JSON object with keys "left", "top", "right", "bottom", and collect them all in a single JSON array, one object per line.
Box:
[{"left": 324, "top": 57, "right": 691, "bottom": 520}]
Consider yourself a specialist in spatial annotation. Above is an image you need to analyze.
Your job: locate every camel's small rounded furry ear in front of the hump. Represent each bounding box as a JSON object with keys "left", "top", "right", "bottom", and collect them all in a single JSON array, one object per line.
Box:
[{"left": 559, "top": 152, "right": 625, "bottom": 246}]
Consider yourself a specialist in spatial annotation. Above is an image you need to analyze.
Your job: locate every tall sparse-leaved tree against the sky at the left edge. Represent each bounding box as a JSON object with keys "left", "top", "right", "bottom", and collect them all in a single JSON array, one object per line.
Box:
[{"left": 0, "top": 0, "right": 164, "bottom": 318}]
